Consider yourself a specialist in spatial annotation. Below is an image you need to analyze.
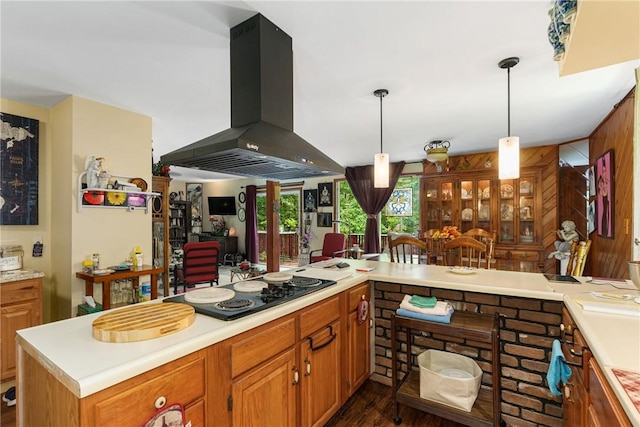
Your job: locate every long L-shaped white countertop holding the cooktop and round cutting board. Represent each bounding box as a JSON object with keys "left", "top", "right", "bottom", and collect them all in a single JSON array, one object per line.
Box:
[{"left": 18, "top": 259, "right": 638, "bottom": 422}]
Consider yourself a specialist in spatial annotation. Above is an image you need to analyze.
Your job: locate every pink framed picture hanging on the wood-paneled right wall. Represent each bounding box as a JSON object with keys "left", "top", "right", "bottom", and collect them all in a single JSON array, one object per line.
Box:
[{"left": 596, "top": 150, "right": 615, "bottom": 239}]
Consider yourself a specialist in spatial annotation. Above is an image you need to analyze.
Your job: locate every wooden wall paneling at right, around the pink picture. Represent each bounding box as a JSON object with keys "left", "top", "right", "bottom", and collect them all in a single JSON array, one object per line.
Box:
[{"left": 587, "top": 91, "right": 635, "bottom": 279}]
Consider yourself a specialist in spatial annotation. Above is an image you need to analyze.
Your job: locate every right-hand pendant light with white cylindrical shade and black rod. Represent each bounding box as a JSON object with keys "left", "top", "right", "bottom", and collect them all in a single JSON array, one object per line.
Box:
[{"left": 498, "top": 57, "right": 520, "bottom": 179}]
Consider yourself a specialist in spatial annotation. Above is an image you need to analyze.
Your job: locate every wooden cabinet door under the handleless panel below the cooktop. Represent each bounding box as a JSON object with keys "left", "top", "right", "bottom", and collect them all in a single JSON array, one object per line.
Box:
[{"left": 231, "top": 348, "right": 300, "bottom": 427}]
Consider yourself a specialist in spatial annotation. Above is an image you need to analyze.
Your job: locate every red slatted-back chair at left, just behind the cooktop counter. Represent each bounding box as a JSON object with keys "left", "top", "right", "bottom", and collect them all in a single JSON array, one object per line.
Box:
[{"left": 173, "top": 242, "right": 220, "bottom": 294}]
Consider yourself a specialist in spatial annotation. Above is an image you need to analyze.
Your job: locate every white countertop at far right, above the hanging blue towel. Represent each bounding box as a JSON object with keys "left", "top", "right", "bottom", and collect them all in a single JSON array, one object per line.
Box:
[{"left": 564, "top": 290, "right": 640, "bottom": 426}]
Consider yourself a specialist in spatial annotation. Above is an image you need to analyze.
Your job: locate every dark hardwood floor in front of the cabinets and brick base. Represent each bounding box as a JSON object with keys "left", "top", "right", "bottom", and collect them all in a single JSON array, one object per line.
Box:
[{"left": 0, "top": 380, "right": 463, "bottom": 427}]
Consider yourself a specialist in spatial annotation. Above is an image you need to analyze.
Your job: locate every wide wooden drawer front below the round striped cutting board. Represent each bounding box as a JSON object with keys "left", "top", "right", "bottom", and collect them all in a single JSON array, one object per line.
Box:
[{"left": 87, "top": 352, "right": 206, "bottom": 426}]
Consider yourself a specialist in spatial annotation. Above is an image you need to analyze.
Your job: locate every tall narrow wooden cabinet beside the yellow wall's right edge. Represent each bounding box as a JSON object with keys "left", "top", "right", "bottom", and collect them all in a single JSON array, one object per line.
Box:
[{"left": 151, "top": 176, "right": 171, "bottom": 296}]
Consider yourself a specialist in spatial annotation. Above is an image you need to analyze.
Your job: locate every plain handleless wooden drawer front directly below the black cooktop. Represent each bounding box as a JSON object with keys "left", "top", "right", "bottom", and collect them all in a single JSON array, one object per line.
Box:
[{"left": 231, "top": 318, "right": 296, "bottom": 378}]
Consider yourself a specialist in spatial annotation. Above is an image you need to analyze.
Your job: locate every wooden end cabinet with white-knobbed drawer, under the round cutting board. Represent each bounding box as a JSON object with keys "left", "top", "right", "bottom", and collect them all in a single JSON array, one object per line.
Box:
[{"left": 18, "top": 349, "right": 208, "bottom": 427}]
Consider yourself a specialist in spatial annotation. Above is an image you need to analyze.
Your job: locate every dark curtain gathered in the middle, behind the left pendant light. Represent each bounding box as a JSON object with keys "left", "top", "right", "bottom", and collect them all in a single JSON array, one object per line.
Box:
[{"left": 345, "top": 162, "right": 405, "bottom": 254}]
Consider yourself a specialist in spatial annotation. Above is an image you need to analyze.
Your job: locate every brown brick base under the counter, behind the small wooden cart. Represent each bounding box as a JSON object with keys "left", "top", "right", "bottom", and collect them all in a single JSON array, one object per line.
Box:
[{"left": 373, "top": 282, "right": 562, "bottom": 427}]
